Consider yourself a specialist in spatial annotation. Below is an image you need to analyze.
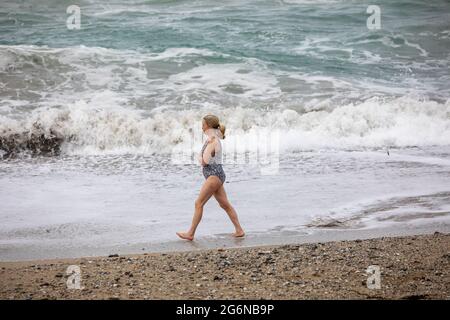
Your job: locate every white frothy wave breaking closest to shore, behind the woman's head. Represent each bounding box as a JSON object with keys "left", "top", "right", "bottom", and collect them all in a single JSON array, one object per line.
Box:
[{"left": 0, "top": 97, "right": 450, "bottom": 154}]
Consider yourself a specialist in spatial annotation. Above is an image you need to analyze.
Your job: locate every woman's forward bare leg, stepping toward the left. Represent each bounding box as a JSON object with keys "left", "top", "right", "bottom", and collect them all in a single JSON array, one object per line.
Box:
[{"left": 177, "top": 176, "right": 221, "bottom": 241}]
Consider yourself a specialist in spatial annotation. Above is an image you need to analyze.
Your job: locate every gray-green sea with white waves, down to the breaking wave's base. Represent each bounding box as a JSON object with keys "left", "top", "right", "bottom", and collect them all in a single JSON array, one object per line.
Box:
[{"left": 0, "top": 0, "right": 450, "bottom": 153}]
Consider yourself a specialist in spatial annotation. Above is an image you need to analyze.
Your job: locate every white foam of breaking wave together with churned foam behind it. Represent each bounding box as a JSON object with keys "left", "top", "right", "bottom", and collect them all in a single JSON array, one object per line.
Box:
[{"left": 0, "top": 44, "right": 450, "bottom": 154}]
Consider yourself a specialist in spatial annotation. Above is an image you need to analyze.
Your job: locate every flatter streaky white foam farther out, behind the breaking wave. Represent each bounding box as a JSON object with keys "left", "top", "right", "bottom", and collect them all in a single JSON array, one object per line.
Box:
[{"left": 0, "top": 42, "right": 448, "bottom": 109}]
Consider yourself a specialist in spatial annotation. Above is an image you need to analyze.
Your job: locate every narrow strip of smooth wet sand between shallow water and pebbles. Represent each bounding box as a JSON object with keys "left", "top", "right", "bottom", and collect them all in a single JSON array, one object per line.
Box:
[{"left": 0, "top": 221, "right": 450, "bottom": 263}]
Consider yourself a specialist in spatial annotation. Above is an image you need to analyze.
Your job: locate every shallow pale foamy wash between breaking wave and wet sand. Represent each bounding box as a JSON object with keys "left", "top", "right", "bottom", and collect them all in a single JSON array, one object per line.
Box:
[{"left": 0, "top": 148, "right": 450, "bottom": 260}]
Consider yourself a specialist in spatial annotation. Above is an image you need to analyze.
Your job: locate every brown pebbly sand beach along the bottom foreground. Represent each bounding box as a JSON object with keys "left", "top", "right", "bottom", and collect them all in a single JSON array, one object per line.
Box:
[{"left": 0, "top": 232, "right": 450, "bottom": 299}]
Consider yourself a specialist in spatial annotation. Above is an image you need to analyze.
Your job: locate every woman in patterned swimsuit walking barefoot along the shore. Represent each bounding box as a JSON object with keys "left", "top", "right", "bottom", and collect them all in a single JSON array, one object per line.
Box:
[{"left": 177, "top": 115, "right": 245, "bottom": 241}]
